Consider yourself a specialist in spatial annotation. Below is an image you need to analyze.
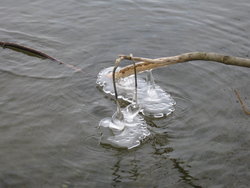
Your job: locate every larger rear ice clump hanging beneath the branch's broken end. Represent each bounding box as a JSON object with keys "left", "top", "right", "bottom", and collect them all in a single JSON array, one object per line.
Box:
[{"left": 96, "top": 67, "right": 176, "bottom": 118}]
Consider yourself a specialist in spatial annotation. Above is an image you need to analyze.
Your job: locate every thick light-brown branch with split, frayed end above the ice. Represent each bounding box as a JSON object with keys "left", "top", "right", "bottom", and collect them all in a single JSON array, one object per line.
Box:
[{"left": 116, "top": 52, "right": 250, "bottom": 79}]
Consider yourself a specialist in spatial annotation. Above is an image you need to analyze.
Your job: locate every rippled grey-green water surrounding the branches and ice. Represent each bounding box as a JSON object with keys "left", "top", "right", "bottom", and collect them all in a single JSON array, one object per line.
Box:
[{"left": 0, "top": 0, "right": 250, "bottom": 188}]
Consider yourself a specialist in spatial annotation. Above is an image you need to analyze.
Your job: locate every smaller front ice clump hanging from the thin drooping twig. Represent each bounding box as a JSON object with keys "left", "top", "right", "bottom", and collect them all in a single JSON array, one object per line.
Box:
[{"left": 99, "top": 104, "right": 150, "bottom": 149}]
